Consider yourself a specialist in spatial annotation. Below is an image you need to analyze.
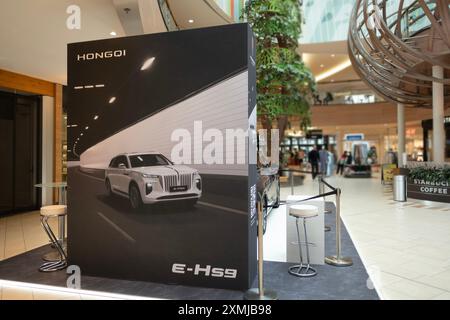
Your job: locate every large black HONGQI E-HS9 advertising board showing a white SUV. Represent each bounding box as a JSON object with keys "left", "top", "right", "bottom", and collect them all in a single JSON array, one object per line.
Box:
[{"left": 68, "top": 24, "right": 257, "bottom": 289}]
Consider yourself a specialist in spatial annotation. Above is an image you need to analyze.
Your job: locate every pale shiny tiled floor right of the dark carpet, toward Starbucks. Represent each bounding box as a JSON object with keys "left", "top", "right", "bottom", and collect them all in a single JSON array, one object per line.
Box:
[{"left": 282, "top": 172, "right": 450, "bottom": 299}]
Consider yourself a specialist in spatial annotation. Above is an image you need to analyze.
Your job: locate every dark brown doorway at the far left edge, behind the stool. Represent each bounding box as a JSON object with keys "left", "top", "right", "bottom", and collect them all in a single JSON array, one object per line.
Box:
[{"left": 0, "top": 90, "right": 42, "bottom": 216}]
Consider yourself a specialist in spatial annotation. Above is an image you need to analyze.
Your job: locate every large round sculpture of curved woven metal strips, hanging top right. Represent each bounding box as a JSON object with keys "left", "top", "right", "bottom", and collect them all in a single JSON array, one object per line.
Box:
[{"left": 348, "top": 0, "right": 450, "bottom": 107}]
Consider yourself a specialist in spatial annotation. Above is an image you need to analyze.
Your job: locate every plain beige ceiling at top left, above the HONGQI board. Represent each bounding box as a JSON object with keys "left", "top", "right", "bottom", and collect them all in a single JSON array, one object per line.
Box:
[{"left": 0, "top": 0, "right": 124, "bottom": 84}]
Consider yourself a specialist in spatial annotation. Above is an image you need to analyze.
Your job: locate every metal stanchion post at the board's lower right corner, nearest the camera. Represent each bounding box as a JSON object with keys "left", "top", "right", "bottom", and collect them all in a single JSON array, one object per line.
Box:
[{"left": 244, "top": 202, "right": 278, "bottom": 300}]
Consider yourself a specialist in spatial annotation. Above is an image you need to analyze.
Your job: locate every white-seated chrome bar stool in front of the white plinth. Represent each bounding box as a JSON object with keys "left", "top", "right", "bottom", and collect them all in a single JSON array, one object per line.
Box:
[{"left": 289, "top": 205, "right": 319, "bottom": 277}]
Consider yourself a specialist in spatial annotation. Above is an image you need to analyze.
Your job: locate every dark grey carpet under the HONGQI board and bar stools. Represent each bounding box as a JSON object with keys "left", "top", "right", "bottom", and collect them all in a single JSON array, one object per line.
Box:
[{"left": 0, "top": 203, "right": 379, "bottom": 300}]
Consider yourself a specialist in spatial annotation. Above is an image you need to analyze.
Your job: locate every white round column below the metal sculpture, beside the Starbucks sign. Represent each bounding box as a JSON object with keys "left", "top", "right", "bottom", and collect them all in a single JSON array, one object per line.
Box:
[{"left": 433, "top": 66, "right": 445, "bottom": 162}]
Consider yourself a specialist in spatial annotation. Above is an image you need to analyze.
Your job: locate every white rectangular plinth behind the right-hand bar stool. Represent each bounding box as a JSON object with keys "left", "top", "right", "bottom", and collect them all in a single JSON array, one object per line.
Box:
[{"left": 286, "top": 195, "right": 325, "bottom": 265}]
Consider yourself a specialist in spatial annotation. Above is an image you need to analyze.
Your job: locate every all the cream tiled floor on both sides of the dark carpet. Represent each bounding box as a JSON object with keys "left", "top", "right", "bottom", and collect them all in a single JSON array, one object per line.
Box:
[{"left": 0, "top": 172, "right": 450, "bottom": 300}]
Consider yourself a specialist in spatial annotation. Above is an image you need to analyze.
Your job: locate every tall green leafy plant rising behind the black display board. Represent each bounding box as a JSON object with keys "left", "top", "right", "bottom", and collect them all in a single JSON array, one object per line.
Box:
[{"left": 244, "top": 0, "right": 316, "bottom": 126}]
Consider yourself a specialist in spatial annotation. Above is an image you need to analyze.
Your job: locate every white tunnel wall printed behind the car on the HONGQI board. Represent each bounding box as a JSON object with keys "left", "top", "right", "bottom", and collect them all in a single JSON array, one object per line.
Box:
[{"left": 81, "top": 72, "right": 249, "bottom": 175}]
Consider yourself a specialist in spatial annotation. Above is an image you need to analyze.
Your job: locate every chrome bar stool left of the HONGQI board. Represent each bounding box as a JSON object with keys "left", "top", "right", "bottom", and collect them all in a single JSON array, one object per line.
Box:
[{"left": 39, "top": 205, "right": 67, "bottom": 272}]
